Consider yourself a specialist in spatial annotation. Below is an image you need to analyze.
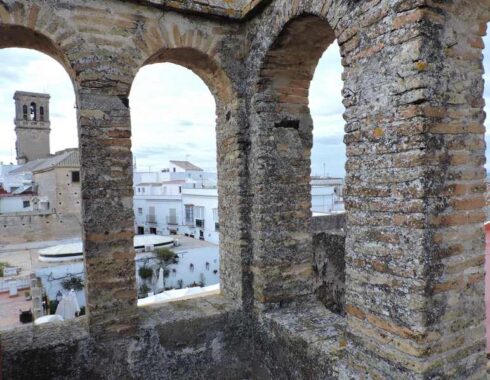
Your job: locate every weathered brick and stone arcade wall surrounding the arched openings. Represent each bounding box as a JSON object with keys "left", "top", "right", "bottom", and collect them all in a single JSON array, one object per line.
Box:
[{"left": 0, "top": 0, "right": 490, "bottom": 379}]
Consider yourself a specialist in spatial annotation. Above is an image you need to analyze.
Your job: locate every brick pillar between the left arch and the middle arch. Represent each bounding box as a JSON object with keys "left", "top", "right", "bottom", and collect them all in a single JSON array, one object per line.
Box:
[{"left": 78, "top": 87, "right": 137, "bottom": 338}]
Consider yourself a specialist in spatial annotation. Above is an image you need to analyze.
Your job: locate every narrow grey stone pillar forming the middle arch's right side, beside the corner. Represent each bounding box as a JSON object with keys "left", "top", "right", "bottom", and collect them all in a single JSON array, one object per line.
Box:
[{"left": 216, "top": 100, "right": 252, "bottom": 307}]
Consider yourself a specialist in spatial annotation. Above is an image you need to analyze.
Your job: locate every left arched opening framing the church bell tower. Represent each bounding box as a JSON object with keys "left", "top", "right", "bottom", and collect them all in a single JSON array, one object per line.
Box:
[{"left": 0, "top": 40, "right": 83, "bottom": 329}]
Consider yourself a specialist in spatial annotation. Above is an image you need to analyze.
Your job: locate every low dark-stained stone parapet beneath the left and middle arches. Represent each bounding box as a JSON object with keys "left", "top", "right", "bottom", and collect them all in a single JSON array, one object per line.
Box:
[{"left": 1, "top": 297, "right": 252, "bottom": 380}]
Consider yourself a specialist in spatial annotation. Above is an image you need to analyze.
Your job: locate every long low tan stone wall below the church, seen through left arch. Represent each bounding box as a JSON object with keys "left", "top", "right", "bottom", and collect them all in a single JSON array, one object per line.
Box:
[{"left": 0, "top": 212, "right": 82, "bottom": 244}]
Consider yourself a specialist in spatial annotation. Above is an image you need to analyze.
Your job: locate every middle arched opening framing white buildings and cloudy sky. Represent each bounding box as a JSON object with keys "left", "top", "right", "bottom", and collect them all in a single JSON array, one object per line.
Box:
[{"left": 130, "top": 48, "right": 226, "bottom": 305}]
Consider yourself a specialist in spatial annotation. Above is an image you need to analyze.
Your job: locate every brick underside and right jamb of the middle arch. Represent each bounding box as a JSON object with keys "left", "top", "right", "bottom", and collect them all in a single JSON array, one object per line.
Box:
[{"left": 129, "top": 41, "right": 248, "bottom": 299}]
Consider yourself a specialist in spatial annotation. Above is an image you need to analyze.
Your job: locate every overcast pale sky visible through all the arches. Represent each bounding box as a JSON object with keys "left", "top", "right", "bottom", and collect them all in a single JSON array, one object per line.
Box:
[{"left": 0, "top": 38, "right": 490, "bottom": 176}]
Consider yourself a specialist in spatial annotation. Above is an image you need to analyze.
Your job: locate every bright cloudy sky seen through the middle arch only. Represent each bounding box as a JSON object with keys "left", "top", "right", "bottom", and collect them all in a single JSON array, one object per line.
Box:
[{"left": 130, "top": 63, "right": 216, "bottom": 170}]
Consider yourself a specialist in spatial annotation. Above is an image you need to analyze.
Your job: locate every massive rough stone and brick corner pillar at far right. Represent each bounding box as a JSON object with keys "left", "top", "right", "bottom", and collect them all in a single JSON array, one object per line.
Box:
[{"left": 341, "top": 1, "right": 486, "bottom": 379}]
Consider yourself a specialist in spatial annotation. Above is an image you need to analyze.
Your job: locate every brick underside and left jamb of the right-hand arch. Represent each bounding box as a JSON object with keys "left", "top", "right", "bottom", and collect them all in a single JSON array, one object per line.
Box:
[{"left": 250, "top": 13, "right": 335, "bottom": 303}]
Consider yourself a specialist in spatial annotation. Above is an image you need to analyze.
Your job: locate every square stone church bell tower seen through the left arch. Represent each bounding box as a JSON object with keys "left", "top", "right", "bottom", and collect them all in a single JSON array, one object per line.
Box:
[{"left": 14, "top": 91, "right": 51, "bottom": 165}]
